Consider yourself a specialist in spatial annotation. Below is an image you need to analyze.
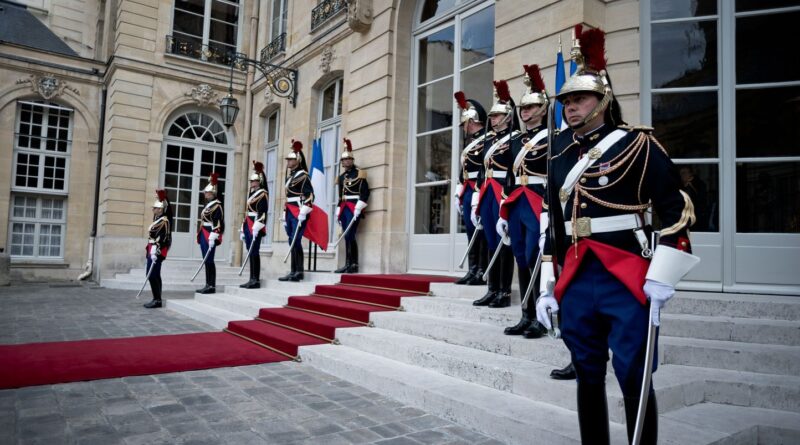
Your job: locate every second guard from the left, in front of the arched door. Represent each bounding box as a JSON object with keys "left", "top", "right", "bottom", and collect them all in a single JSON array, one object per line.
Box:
[{"left": 197, "top": 172, "right": 225, "bottom": 294}]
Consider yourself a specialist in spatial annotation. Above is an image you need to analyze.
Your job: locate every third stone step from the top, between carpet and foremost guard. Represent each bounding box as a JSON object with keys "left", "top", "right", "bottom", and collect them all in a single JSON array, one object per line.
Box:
[{"left": 371, "top": 312, "right": 570, "bottom": 368}]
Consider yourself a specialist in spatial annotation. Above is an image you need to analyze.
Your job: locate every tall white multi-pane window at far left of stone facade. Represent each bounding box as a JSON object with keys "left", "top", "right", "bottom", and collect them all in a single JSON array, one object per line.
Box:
[{"left": 9, "top": 101, "right": 72, "bottom": 258}]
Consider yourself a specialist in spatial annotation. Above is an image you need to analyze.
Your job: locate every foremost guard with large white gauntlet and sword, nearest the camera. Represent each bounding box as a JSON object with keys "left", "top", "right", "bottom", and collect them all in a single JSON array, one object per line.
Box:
[{"left": 536, "top": 25, "right": 699, "bottom": 444}]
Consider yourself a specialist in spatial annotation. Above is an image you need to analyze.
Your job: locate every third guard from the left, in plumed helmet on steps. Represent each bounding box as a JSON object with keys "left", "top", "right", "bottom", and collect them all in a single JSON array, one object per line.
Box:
[{"left": 239, "top": 161, "right": 269, "bottom": 289}]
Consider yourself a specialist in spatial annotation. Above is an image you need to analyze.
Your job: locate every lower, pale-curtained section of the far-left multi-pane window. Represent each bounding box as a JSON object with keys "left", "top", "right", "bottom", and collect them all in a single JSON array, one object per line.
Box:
[{"left": 9, "top": 194, "right": 67, "bottom": 259}]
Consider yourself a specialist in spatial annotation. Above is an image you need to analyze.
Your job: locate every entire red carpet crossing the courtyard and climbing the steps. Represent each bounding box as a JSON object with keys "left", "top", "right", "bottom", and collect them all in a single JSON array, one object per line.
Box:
[{"left": 0, "top": 274, "right": 455, "bottom": 389}]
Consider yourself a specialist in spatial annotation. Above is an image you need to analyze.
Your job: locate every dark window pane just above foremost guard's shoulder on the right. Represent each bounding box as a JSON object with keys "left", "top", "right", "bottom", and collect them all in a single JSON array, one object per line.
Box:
[{"left": 653, "top": 92, "right": 719, "bottom": 159}]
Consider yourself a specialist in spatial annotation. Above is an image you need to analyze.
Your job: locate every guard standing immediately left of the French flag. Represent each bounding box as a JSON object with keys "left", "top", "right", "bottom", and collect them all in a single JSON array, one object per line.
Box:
[{"left": 278, "top": 139, "right": 314, "bottom": 281}]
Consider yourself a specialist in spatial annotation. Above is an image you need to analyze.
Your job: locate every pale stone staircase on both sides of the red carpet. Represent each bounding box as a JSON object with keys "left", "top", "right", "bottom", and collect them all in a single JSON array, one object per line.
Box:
[{"left": 103, "top": 266, "right": 800, "bottom": 444}]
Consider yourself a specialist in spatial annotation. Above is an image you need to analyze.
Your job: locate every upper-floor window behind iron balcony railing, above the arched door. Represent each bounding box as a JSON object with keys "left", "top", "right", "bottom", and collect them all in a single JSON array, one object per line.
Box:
[{"left": 167, "top": 0, "right": 239, "bottom": 64}]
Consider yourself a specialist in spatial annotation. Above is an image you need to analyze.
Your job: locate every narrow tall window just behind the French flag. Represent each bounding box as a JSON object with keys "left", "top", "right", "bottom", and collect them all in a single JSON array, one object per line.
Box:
[{"left": 318, "top": 79, "right": 344, "bottom": 239}]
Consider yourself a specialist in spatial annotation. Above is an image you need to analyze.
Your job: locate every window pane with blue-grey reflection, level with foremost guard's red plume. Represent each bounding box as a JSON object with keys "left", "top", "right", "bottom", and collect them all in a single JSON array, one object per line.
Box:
[{"left": 651, "top": 20, "right": 717, "bottom": 88}]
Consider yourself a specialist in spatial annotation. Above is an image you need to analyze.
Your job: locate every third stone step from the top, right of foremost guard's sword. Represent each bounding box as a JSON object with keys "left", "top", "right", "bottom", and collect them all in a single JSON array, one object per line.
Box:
[{"left": 659, "top": 337, "right": 800, "bottom": 376}]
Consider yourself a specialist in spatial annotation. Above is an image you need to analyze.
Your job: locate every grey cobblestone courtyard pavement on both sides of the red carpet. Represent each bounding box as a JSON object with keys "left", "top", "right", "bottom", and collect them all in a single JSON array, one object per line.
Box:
[{"left": 0, "top": 284, "right": 500, "bottom": 445}]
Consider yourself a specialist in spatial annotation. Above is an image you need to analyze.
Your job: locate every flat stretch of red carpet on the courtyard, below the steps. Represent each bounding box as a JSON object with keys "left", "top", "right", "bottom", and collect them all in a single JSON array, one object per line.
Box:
[{"left": 0, "top": 332, "right": 287, "bottom": 389}]
